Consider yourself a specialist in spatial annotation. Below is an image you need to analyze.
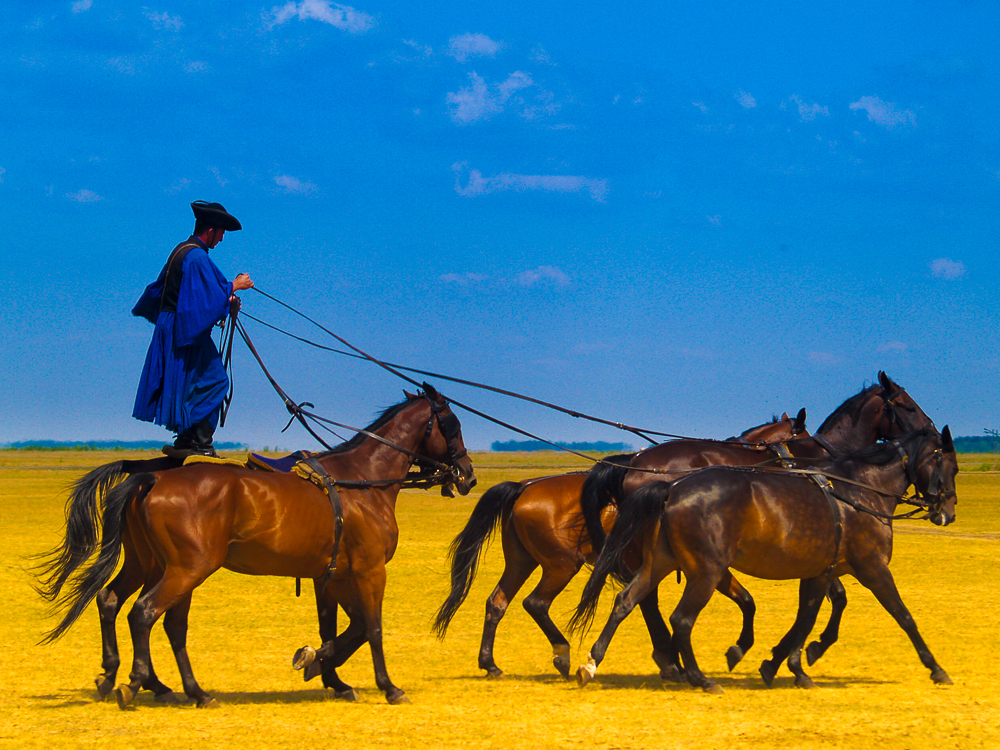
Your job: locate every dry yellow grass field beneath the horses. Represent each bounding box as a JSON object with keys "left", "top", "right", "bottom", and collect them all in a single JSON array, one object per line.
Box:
[{"left": 0, "top": 451, "right": 1000, "bottom": 750}]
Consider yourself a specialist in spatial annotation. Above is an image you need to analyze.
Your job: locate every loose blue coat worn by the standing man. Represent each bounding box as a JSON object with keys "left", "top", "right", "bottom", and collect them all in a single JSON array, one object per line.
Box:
[{"left": 132, "top": 237, "right": 233, "bottom": 433}]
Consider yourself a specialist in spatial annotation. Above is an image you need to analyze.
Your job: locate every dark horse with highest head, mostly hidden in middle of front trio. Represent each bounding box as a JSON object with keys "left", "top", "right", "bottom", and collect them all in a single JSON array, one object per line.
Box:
[{"left": 581, "top": 372, "right": 934, "bottom": 670}]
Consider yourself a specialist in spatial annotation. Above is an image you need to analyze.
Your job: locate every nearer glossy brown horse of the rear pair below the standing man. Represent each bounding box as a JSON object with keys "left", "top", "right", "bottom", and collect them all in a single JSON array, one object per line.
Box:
[{"left": 41, "top": 384, "right": 475, "bottom": 708}]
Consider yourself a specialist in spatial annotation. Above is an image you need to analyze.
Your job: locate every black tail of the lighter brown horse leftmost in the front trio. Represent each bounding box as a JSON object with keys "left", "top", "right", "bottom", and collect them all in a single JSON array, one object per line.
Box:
[{"left": 434, "top": 482, "right": 525, "bottom": 638}]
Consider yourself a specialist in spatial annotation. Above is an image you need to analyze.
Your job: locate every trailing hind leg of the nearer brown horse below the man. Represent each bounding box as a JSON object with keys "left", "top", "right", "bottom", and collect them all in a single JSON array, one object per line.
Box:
[{"left": 115, "top": 568, "right": 218, "bottom": 709}]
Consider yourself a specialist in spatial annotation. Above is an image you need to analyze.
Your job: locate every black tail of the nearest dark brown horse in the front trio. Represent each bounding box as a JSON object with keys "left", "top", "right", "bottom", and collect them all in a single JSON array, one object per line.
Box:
[{"left": 569, "top": 482, "right": 673, "bottom": 632}]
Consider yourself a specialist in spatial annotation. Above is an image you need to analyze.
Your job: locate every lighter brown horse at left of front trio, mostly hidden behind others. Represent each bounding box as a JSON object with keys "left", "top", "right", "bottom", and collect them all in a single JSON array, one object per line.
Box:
[{"left": 434, "top": 409, "right": 806, "bottom": 677}]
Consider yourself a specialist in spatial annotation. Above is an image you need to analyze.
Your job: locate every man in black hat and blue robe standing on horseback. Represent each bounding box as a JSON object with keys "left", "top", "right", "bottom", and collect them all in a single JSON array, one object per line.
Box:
[{"left": 132, "top": 201, "right": 253, "bottom": 457}]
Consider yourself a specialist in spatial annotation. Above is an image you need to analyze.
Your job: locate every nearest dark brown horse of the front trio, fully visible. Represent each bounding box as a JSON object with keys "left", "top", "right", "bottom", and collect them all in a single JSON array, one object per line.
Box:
[{"left": 571, "top": 427, "right": 958, "bottom": 692}]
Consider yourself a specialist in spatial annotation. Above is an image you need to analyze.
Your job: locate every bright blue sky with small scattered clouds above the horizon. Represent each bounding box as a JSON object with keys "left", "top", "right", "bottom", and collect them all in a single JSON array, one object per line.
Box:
[{"left": 0, "top": 0, "right": 1000, "bottom": 448}]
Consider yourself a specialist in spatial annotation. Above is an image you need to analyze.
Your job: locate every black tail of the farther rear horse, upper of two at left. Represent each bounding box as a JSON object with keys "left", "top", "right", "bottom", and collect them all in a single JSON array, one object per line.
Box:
[{"left": 35, "top": 461, "right": 128, "bottom": 602}]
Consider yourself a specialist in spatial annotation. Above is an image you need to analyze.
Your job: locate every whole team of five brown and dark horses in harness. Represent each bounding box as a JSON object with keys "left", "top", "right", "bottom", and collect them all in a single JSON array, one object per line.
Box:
[{"left": 37, "top": 373, "right": 958, "bottom": 708}]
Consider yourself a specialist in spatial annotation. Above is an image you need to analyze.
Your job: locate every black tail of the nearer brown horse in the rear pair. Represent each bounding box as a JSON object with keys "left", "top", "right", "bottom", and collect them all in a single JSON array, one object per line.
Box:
[{"left": 38, "top": 467, "right": 156, "bottom": 643}]
